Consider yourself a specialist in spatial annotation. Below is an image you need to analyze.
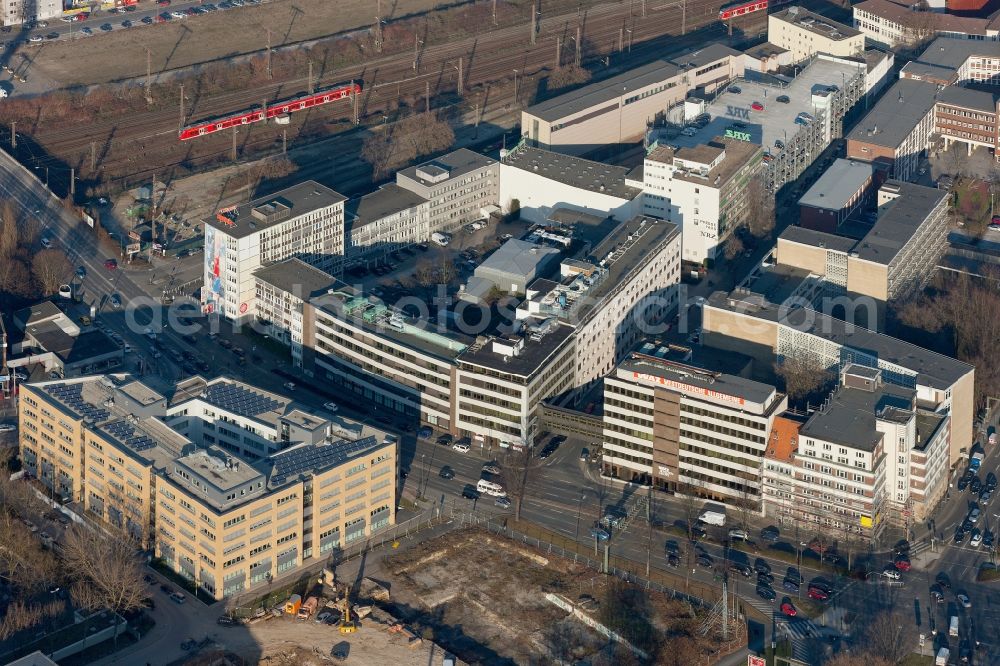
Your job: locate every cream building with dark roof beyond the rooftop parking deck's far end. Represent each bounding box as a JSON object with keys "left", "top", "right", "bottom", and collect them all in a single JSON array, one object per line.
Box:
[{"left": 767, "top": 7, "right": 865, "bottom": 62}]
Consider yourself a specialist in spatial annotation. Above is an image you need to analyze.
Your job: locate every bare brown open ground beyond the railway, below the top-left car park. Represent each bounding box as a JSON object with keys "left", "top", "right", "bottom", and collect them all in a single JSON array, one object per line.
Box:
[{"left": 21, "top": 0, "right": 461, "bottom": 87}]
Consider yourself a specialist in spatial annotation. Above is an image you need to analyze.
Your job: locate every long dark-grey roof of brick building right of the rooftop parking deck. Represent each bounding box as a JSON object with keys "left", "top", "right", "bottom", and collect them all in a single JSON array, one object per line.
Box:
[{"left": 847, "top": 79, "right": 938, "bottom": 150}]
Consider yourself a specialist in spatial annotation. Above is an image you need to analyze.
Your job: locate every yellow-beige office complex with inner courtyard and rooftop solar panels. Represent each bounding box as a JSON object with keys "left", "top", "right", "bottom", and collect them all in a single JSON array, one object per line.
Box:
[{"left": 19, "top": 375, "right": 396, "bottom": 599}]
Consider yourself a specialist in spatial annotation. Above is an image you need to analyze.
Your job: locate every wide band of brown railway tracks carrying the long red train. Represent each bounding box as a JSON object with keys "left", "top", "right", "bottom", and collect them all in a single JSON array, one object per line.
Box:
[{"left": 27, "top": 0, "right": 766, "bottom": 187}]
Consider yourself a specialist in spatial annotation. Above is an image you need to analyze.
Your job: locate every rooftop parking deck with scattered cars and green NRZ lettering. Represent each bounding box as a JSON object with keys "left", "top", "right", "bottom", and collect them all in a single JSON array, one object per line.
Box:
[{"left": 661, "top": 58, "right": 865, "bottom": 148}]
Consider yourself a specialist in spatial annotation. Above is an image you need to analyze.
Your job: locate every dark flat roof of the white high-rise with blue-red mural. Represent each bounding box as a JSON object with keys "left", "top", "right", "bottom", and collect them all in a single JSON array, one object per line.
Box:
[{"left": 204, "top": 180, "right": 347, "bottom": 238}]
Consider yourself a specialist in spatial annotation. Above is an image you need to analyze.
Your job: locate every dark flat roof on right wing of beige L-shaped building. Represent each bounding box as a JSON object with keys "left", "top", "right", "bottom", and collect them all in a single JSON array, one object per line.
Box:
[{"left": 854, "top": 180, "right": 948, "bottom": 265}]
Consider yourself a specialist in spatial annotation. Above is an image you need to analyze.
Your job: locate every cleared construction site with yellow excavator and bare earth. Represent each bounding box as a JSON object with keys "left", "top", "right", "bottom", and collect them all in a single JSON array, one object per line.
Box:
[{"left": 211, "top": 527, "right": 746, "bottom": 666}]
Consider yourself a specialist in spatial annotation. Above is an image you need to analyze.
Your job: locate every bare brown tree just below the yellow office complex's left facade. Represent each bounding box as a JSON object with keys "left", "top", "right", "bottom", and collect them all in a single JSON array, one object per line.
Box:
[{"left": 63, "top": 526, "right": 146, "bottom": 613}]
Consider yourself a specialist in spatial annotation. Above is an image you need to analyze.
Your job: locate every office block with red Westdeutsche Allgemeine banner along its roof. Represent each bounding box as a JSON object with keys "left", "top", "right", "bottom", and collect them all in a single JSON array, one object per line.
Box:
[{"left": 601, "top": 344, "right": 788, "bottom": 508}]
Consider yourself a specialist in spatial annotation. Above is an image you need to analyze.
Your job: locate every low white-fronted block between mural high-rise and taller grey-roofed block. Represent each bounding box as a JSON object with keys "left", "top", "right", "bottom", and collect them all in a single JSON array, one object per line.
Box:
[{"left": 345, "top": 183, "right": 431, "bottom": 265}]
